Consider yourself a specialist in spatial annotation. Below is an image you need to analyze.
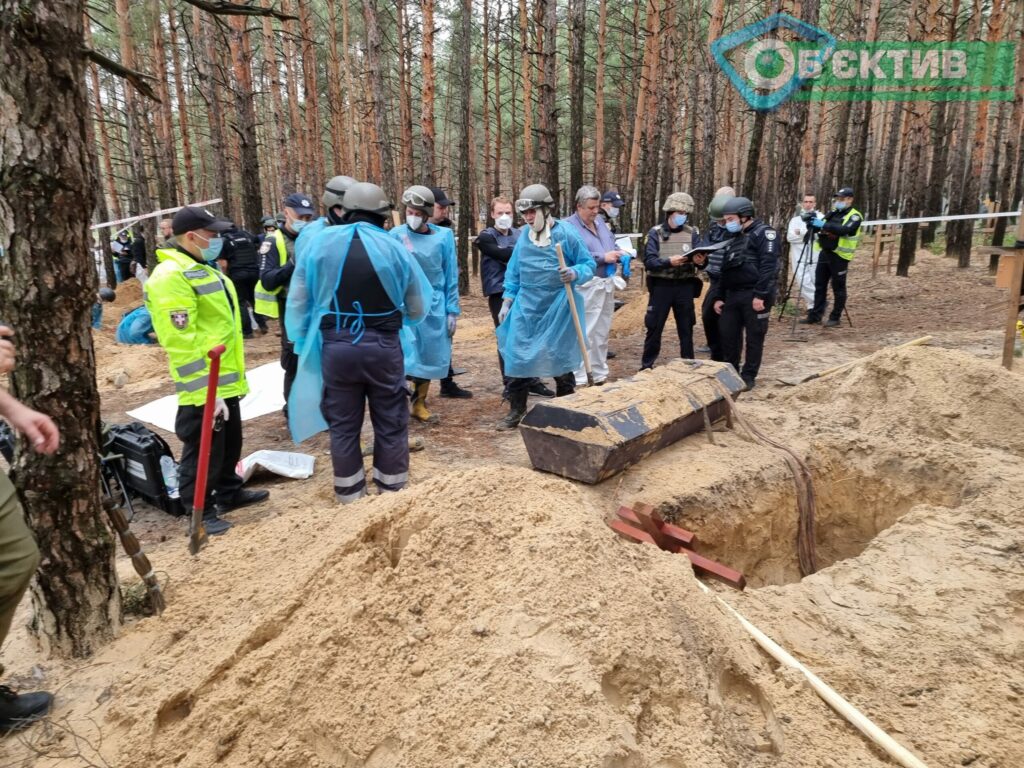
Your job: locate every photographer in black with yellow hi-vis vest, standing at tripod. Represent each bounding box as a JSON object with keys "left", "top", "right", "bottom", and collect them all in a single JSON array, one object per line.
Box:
[{"left": 800, "top": 186, "right": 863, "bottom": 328}]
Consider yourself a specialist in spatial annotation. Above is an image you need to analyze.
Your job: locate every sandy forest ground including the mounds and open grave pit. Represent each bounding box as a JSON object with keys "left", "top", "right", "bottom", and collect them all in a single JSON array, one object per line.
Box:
[{"left": 0, "top": 250, "right": 1024, "bottom": 768}]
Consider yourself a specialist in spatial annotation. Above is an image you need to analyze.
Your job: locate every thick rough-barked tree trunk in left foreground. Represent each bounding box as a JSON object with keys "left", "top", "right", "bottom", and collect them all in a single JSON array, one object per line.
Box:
[{"left": 0, "top": 0, "right": 121, "bottom": 656}]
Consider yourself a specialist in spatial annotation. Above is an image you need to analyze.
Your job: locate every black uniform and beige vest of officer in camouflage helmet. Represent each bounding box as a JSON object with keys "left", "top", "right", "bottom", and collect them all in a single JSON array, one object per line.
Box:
[{"left": 640, "top": 221, "right": 703, "bottom": 370}]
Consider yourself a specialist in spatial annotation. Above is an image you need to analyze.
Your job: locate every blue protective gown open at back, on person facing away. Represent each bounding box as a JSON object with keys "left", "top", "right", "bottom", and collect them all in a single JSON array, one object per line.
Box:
[{"left": 285, "top": 222, "right": 433, "bottom": 442}]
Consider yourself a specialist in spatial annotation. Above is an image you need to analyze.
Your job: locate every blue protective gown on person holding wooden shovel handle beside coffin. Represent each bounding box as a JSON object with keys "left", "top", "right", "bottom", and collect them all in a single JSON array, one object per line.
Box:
[{"left": 495, "top": 221, "right": 596, "bottom": 379}]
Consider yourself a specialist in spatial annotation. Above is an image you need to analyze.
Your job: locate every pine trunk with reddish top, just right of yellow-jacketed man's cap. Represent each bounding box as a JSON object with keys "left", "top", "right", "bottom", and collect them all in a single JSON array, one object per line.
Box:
[{"left": 228, "top": 16, "right": 263, "bottom": 231}]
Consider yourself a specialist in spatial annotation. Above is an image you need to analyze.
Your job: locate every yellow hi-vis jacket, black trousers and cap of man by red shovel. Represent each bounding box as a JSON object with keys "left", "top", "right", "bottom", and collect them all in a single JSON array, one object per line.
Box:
[{"left": 144, "top": 208, "right": 249, "bottom": 516}]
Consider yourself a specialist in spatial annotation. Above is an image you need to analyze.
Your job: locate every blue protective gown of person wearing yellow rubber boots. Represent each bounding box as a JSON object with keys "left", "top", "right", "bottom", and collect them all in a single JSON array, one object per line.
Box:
[{"left": 391, "top": 224, "right": 462, "bottom": 379}]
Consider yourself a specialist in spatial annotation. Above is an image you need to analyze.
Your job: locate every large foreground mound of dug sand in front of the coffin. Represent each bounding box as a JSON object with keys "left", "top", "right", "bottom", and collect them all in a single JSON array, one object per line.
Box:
[{"left": 108, "top": 467, "right": 883, "bottom": 768}]
